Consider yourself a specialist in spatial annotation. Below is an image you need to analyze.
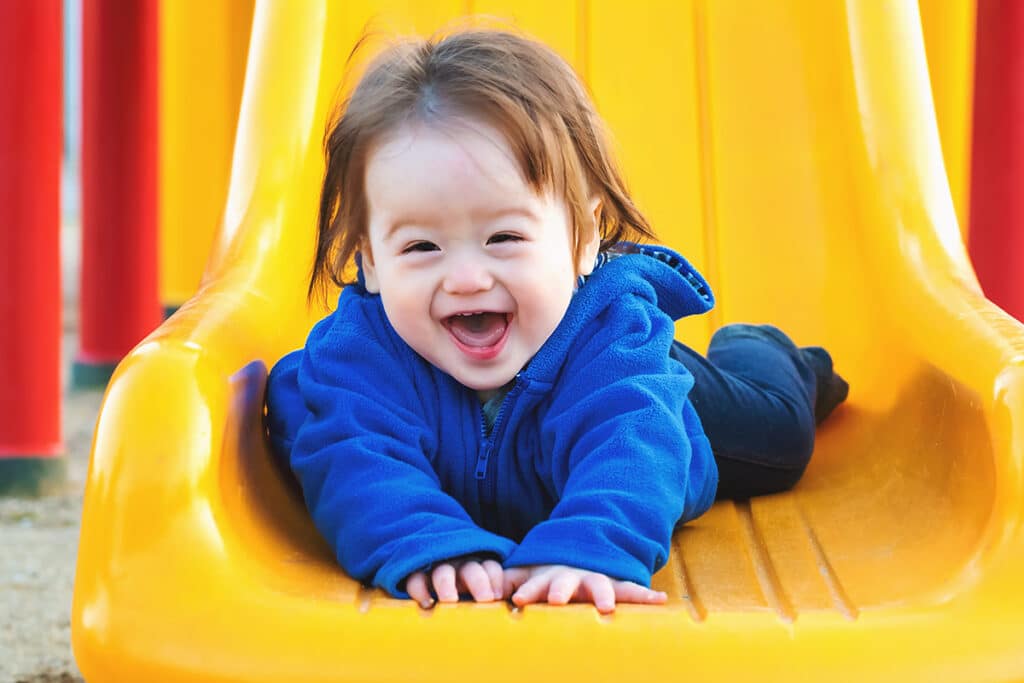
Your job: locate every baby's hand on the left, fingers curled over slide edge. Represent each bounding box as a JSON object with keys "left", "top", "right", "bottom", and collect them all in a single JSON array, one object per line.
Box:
[{"left": 406, "top": 555, "right": 504, "bottom": 609}]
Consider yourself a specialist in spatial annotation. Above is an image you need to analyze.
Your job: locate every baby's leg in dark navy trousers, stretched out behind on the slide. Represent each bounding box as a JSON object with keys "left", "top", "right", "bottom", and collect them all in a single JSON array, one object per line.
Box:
[{"left": 671, "top": 325, "right": 847, "bottom": 498}]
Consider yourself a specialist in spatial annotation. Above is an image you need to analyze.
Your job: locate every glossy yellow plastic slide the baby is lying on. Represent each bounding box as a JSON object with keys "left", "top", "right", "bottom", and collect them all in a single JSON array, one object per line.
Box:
[{"left": 73, "top": 0, "right": 1024, "bottom": 683}]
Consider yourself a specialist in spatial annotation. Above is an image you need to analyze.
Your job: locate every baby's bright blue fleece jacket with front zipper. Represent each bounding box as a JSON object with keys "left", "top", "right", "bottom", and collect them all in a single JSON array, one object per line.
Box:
[{"left": 267, "top": 246, "right": 718, "bottom": 597}]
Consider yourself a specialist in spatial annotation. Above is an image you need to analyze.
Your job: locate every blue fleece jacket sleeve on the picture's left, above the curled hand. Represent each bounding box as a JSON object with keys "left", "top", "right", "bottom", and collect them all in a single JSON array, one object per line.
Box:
[{"left": 267, "top": 305, "right": 515, "bottom": 598}]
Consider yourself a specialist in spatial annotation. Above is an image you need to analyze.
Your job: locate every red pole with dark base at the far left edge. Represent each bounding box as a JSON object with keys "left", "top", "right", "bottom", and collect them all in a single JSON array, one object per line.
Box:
[{"left": 0, "top": 0, "right": 63, "bottom": 494}]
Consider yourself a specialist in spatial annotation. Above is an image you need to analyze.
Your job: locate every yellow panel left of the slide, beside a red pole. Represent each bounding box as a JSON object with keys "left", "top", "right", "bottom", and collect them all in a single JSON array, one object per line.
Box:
[{"left": 158, "top": 0, "right": 253, "bottom": 314}]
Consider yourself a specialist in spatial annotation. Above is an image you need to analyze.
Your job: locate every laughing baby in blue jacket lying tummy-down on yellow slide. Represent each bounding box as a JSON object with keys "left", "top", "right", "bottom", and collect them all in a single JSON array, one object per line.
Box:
[{"left": 267, "top": 31, "right": 847, "bottom": 612}]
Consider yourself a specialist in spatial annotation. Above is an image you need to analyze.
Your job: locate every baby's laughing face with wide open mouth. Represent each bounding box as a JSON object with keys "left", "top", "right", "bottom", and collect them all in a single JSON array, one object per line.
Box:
[{"left": 362, "top": 122, "right": 599, "bottom": 397}]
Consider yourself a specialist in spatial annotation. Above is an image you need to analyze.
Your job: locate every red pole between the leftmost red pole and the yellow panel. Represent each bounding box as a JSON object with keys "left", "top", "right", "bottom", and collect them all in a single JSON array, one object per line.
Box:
[{"left": 73, "top": 0, "right": 162, "bottom": 386}]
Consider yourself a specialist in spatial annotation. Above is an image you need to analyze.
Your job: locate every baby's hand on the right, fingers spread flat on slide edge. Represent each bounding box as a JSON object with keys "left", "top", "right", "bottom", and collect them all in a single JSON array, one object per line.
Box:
[{"left": 504, "top": 564, "right": 668, "bottom": 614}]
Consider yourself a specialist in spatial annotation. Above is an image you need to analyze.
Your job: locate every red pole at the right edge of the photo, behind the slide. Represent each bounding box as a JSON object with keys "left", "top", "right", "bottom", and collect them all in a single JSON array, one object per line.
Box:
[{"left": 968, "top": 0, "right": 1024, "bottom": 321}]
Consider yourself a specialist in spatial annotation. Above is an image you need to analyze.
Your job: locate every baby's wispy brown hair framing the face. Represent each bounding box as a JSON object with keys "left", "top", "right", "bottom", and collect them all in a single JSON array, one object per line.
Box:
[{"left": 308, "top": 30, "right": 654, "bottom": 298}]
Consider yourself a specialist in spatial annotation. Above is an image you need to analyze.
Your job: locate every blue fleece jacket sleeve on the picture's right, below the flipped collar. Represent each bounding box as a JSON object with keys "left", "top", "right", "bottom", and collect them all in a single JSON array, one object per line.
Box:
[{"left": 505, "top": 293, "right": 718, "bottom": 586}]
